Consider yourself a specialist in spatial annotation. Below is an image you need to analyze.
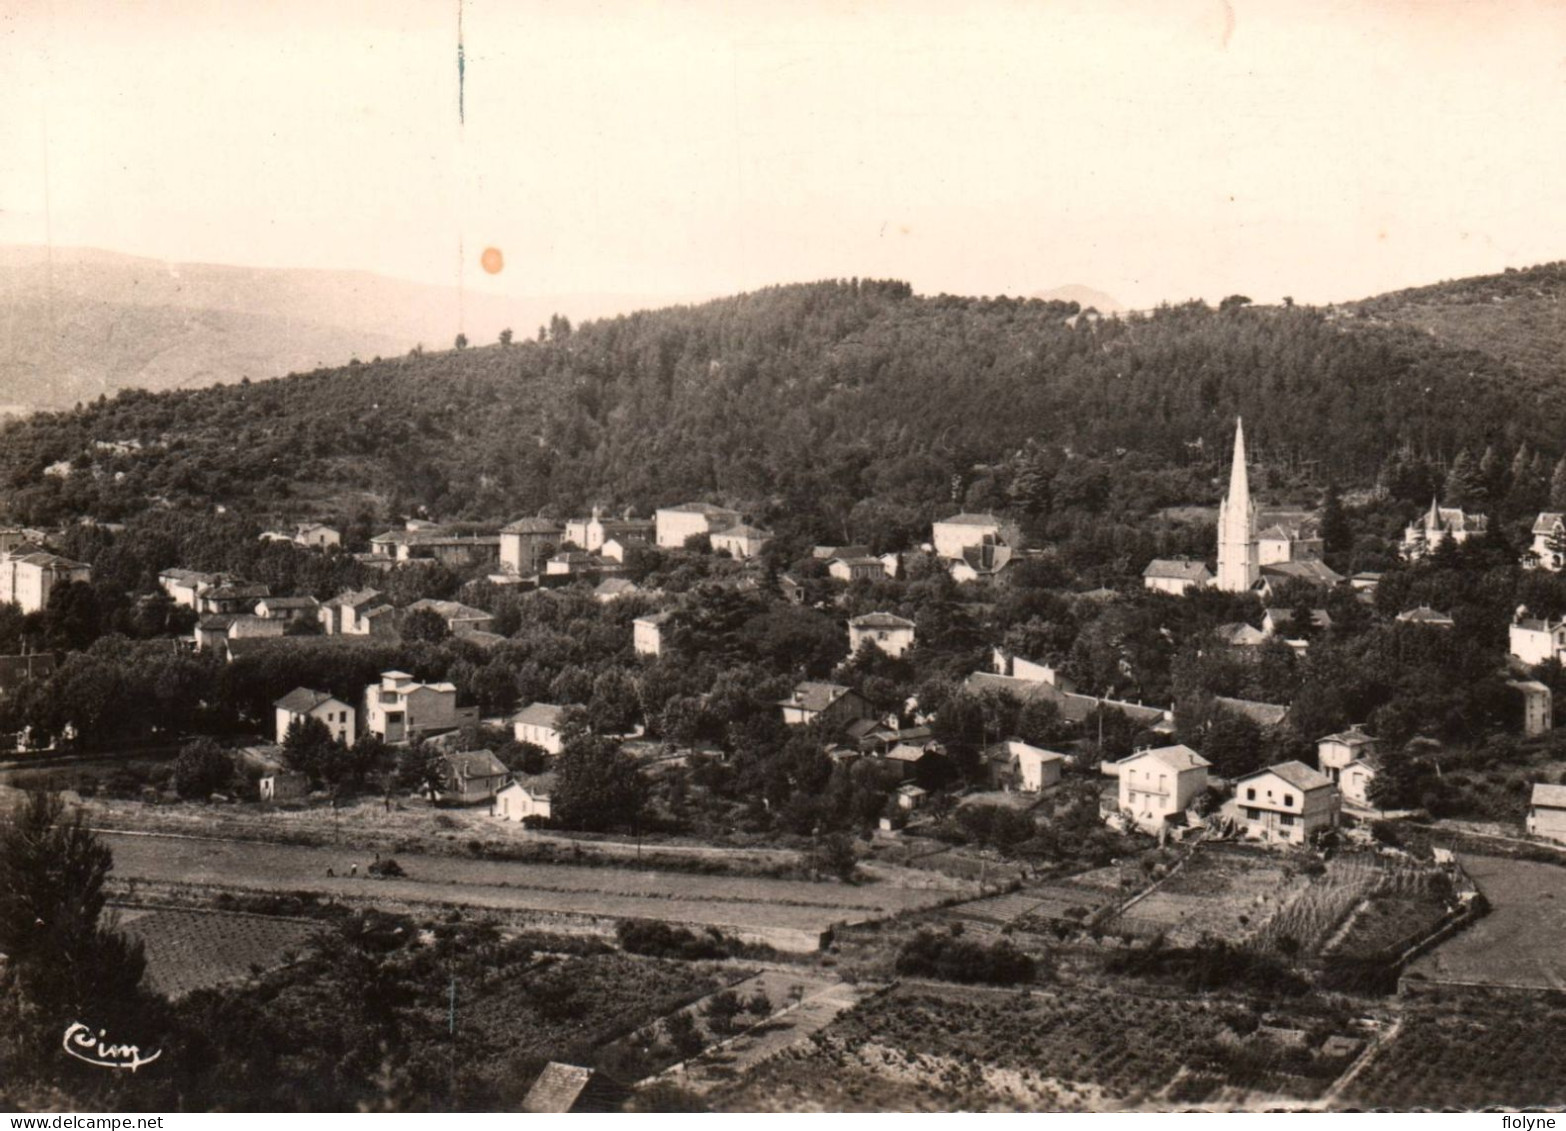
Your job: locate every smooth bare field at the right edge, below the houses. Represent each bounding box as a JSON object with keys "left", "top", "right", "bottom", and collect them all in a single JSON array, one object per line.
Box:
[{"left": 1405, "top": 855, "right": 1566, "bottom": 990}]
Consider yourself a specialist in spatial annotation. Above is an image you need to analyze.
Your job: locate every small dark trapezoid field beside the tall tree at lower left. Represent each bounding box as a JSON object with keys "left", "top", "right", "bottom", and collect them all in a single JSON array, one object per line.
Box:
[{"left": 121, "top": 910, "right": 319, "bottom": 998}]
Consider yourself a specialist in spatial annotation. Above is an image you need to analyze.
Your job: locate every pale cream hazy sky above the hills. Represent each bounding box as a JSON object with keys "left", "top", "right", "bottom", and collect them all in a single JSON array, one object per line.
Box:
[{"left": 0, "top": 0, "right": 1566, "bottom": 307}]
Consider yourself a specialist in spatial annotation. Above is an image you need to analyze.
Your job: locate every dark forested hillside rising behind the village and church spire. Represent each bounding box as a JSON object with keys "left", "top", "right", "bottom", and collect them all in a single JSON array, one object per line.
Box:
[{"left": 0, "top": 269, "right": 1566, "bottom": 540}]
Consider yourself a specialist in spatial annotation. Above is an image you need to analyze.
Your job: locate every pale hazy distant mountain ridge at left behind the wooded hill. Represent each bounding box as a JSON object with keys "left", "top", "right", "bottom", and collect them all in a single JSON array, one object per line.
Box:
[{"left": 0, "top": 246, "right": 689, "bottom": 409}]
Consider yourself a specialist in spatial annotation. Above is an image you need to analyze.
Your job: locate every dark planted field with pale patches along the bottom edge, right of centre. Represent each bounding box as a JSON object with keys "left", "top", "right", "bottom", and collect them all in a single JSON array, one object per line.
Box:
[{"left": 709, "top": 982, "right": 1365, "bottom": 1111}]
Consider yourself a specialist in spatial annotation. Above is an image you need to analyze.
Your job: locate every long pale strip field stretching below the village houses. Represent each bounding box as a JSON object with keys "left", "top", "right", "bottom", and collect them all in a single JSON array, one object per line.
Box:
[{"left": 102, "top": 833, "right": 951, "bottom": 949}]
